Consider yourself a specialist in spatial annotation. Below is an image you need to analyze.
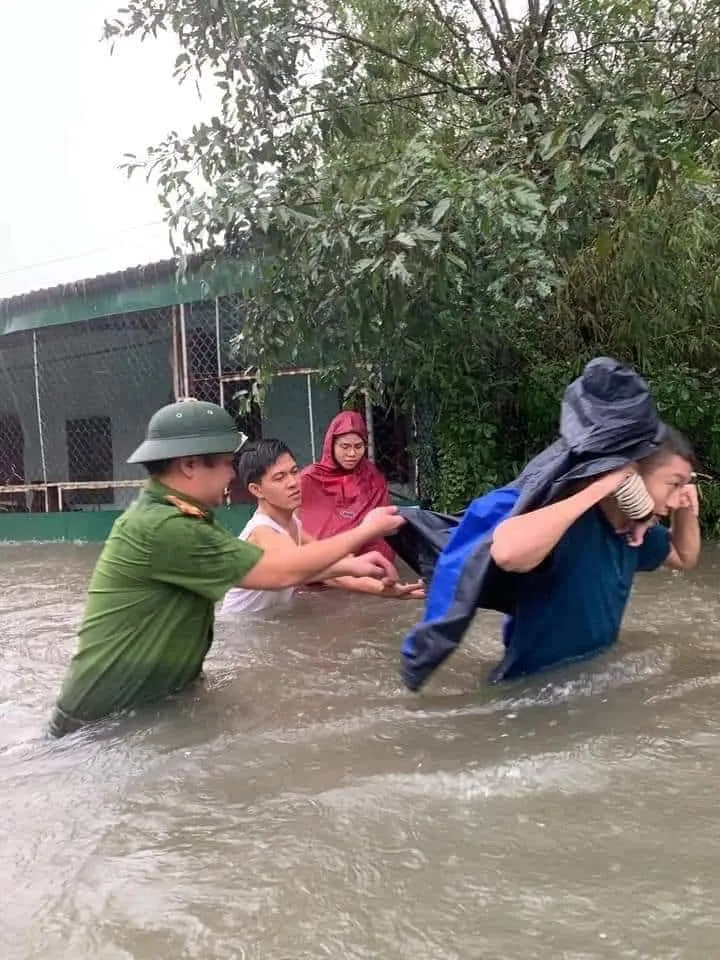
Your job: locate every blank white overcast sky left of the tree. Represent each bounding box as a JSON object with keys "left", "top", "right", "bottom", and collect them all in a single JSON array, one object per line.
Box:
[{"left": 0, "top": 0, "right": 203, "bottom": 298}]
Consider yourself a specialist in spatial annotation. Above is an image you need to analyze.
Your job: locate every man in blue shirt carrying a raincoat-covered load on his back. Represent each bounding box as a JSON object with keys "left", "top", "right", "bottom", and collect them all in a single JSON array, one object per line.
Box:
[{"left": 401, "top": 357, "right": 701, "bottom": 690}]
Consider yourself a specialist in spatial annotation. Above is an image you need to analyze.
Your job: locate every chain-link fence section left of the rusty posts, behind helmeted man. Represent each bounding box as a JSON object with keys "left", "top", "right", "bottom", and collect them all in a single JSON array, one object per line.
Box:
[{"left": 0, "top": 308, "right": 174, "bottom": 512}]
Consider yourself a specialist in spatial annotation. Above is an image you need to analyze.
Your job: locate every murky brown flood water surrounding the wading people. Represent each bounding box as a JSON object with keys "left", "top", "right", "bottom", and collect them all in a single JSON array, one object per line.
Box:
[{"left": 0, "top": 544, "right": 720, "bottom": 960}]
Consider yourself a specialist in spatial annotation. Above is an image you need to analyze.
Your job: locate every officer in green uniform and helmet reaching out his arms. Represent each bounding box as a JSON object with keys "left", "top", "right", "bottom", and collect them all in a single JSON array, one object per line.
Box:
[{"left": 50, "top": 400, "right": 403, "bottom": 736}]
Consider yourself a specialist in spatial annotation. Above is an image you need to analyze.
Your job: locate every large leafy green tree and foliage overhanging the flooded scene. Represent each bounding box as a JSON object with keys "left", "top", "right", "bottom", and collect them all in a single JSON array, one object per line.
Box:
[{"left": 105, "top": 0, "right": 720, "bottom": 528}]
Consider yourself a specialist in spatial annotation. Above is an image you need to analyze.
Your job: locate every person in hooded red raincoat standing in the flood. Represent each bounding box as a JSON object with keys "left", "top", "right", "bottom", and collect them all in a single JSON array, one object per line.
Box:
[{"left": 299, "top": 410, "right": 395, "bottom": 560}]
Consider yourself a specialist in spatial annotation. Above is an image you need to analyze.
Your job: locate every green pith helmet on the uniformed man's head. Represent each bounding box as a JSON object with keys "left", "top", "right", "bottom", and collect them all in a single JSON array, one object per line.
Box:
[{"left": 127, "top": 397, "right": 247, "bottom": 463}]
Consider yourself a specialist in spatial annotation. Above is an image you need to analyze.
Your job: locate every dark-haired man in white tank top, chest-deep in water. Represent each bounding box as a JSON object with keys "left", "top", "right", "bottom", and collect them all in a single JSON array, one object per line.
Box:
[{"left": 220, "top": 439, "right": 425, "bottom": 615}]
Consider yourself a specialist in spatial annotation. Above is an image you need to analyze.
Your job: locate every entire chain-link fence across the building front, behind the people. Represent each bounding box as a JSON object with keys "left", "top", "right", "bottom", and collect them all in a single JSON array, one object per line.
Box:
[{"left": 0, "top": 297, "right": 424, "bottom": 512}]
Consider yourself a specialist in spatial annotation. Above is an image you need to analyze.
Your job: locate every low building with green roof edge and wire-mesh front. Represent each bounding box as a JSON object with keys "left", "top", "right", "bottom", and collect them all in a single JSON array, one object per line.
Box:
[{"left": 0, "top": 255, "right": 413, "bottom": 541}]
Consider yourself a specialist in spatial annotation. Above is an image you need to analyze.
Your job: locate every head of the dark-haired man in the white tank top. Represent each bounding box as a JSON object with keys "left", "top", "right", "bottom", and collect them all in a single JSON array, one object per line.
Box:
[{"left": 237, "top": 439, "right": 301, "bottom": 510}]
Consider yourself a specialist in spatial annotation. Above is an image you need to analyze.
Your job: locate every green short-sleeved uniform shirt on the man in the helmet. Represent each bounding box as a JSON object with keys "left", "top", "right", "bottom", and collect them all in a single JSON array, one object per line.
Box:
[{"left": 51, "top": 480, "right": 262, "bottom": 735}]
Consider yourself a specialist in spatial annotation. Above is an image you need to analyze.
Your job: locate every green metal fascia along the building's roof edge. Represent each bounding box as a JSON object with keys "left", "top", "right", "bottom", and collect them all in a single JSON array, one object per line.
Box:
[{"left": 0, "top": 256, "right": 254, "bottom": 336}]
